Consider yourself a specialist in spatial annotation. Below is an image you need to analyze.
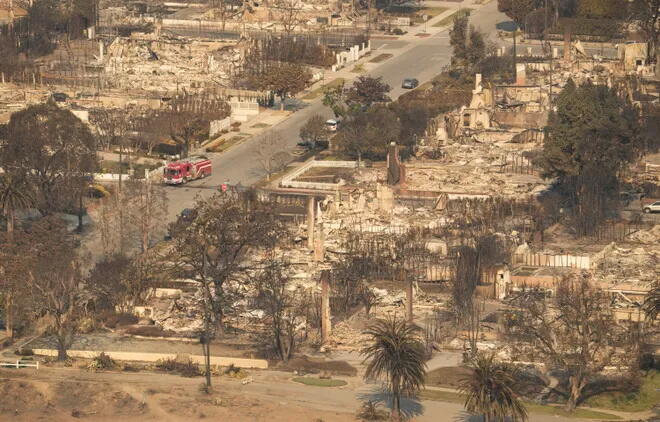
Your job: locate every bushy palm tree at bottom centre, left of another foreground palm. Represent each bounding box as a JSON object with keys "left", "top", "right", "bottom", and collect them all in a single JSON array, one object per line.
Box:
[{"left": 360, "top": 316, "right": 426, "bottom": 418}]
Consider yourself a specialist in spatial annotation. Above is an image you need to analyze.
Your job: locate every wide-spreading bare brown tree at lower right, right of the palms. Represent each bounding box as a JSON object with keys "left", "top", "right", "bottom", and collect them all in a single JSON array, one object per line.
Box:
[{"left": 507, "top": 272, "right": 634, "bottom": 411}]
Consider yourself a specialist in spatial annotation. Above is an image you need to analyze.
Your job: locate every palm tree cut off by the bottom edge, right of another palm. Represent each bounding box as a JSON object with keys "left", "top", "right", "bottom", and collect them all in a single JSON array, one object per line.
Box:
[{"left": 459, "top": 354, "right": 527, "bottom": 422}]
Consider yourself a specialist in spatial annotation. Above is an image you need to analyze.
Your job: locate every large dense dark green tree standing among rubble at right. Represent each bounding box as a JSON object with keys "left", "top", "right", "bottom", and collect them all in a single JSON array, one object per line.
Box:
[{"left": 539, "top": 81, "right": 642, "bottom": 235}]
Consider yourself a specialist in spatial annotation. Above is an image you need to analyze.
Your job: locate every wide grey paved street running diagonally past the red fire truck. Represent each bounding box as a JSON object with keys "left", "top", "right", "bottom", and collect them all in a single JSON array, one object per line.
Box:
[{"left": 162, "top": 1, "right": 507, "bottom": 219}]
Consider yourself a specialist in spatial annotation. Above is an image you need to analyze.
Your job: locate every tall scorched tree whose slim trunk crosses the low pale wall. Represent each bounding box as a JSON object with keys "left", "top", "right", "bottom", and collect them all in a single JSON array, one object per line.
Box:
[{"left": 172, "top": 191, "right": 286, "bottom": 388}]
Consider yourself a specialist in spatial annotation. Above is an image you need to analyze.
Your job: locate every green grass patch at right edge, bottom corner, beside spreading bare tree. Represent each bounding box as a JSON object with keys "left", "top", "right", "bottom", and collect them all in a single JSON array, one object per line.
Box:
[{"left": 586, "top": 371, "right": 660, "bottom": 412}]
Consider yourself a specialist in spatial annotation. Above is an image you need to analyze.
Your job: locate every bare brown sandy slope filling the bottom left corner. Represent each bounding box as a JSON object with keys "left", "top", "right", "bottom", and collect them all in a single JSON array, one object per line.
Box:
[{"left": 0, "top": 368, "right": 354, "bottom": 422}]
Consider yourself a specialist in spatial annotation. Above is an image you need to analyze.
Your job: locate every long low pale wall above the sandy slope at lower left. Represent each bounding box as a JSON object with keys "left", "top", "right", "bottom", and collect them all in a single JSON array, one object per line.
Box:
[{"left": 32, "top": 349, "right": 268, "bottom": 369}]
